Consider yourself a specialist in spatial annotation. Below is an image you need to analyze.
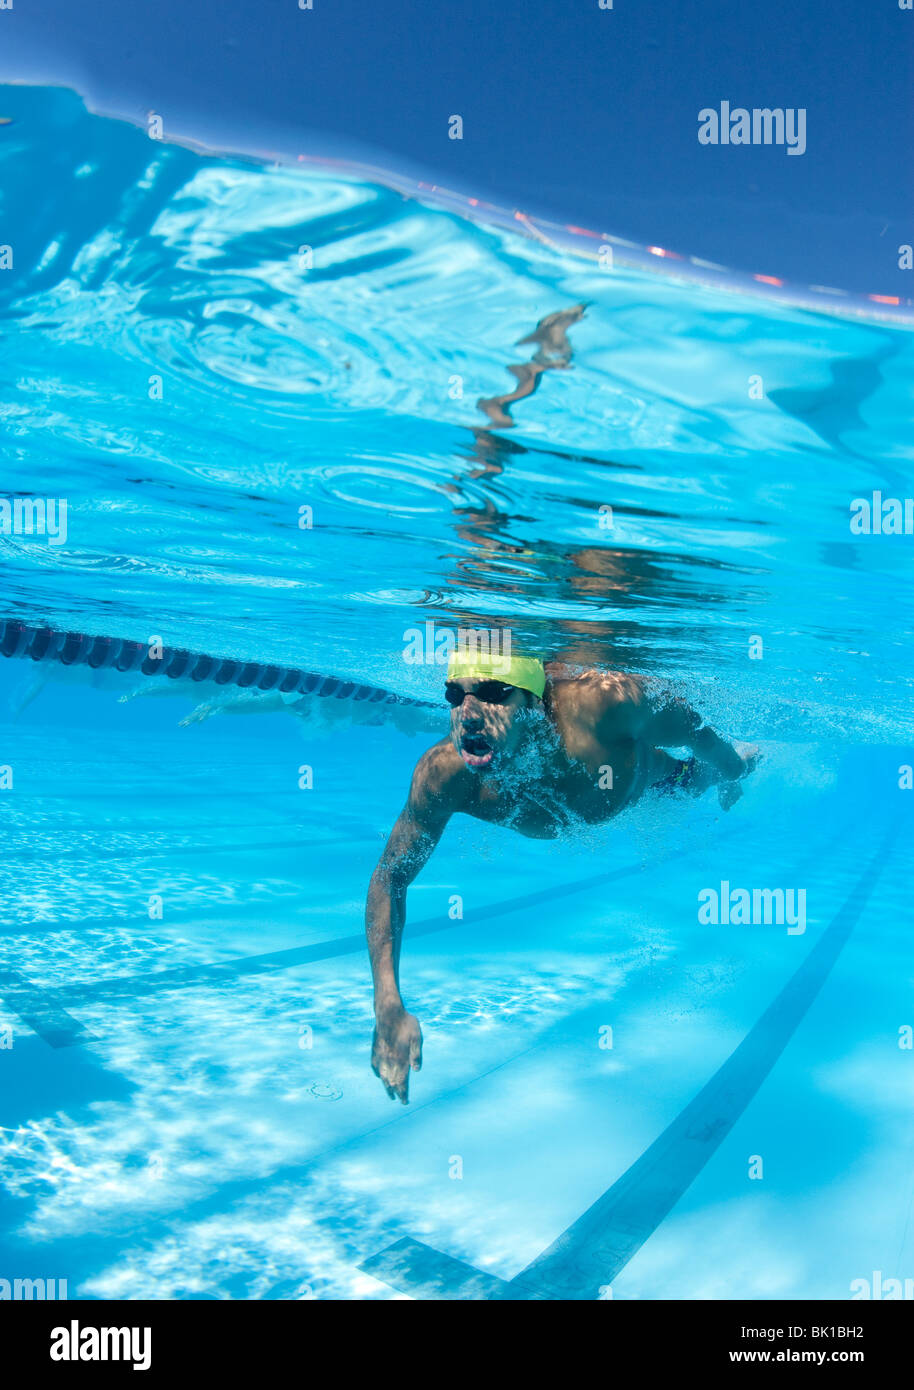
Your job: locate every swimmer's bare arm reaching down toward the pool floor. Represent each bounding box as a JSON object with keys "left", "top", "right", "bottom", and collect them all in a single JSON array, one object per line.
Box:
[{"left": 365, "top": 748, "right": 451, "bottom": 1105}]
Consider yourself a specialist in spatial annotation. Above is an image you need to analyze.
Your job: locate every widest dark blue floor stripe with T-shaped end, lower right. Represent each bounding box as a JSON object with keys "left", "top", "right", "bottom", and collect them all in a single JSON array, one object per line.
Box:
[{"left": 358, "top": 821, "right": 900, "bottom": 1300}]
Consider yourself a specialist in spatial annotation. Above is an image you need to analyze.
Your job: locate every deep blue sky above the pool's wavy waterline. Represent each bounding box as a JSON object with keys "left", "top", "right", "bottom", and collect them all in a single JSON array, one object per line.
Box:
[{"left": 0, "top": 0, "right": 914, "bottom": 296}]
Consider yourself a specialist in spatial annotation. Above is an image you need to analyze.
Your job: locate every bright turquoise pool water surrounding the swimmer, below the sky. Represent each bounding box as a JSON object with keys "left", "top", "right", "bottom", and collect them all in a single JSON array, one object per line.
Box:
[{"left": 0, "top": 88, "right": 914, "bottom": 1300}]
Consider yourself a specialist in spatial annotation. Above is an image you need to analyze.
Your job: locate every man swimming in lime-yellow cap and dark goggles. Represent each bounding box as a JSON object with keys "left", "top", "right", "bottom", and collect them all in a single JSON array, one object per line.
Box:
[{"left": 365, "top": 649, "right": 757, "bottom": 1105}]
